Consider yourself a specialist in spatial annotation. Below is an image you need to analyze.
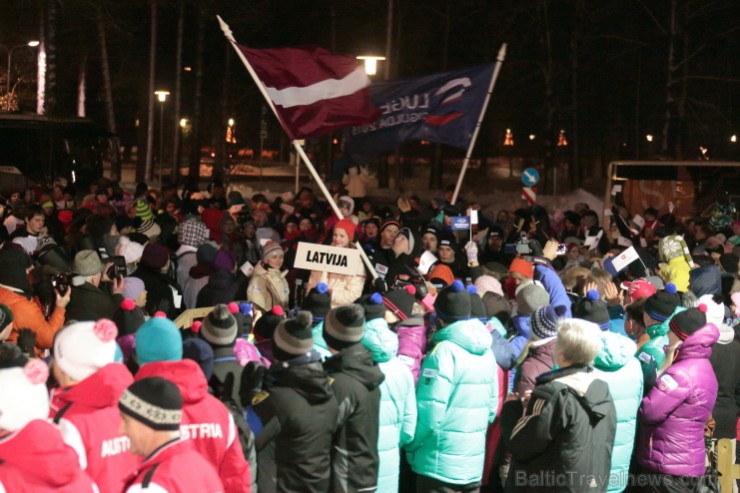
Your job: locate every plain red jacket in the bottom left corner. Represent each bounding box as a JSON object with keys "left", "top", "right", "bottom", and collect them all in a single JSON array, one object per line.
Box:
[{"left": 0, "top": 419, "right": 98, "bottom": 493}]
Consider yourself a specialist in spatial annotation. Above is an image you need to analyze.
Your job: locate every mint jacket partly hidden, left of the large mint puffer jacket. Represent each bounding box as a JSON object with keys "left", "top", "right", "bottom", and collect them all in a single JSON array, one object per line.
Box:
[{"left": 362, "top": 318, "right": 416, "bottom": 492}]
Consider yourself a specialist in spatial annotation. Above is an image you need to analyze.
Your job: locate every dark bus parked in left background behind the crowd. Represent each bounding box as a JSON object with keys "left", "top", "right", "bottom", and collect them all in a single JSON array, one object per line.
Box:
[{"left": 0, "top": 114, "right": 115, "bottom": 197}]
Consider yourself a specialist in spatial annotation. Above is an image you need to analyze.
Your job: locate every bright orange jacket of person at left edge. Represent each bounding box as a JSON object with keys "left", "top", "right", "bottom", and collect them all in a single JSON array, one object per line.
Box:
[{"left": 0, "top": 284, "right": 66, "bottom": 353}]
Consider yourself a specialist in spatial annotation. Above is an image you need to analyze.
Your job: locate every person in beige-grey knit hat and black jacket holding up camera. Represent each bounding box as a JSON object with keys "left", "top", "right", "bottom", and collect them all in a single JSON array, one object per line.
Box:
[{"left": 66, "top": 250, "right": 125, "bottom": 322}]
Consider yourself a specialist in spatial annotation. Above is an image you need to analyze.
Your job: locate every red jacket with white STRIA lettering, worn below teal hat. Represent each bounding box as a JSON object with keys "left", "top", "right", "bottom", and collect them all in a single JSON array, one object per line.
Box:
[{"left": 136, "top": 359, "right": 251, "bottom": 493}]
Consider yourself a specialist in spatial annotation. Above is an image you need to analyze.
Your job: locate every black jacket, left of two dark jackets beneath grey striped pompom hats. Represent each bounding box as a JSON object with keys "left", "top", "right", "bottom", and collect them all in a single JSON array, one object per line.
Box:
[{"left": 252, "top": 353, "right": 338, "bottom": 493}]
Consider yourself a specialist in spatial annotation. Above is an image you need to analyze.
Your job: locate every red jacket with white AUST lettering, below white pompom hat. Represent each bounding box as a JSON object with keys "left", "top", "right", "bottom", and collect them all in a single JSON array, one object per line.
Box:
[{"left": 49, "top": 363, "right": 141, "bottom": 492}]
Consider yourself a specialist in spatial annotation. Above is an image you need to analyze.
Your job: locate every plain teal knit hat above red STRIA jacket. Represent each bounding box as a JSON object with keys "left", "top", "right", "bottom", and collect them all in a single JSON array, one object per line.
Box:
[{"left": 135, "top": 312, "right": 182, "bottom": 365}]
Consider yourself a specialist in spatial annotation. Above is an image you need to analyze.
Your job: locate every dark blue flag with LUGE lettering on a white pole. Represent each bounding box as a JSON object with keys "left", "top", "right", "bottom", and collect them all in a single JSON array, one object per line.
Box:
[{"left": 344, "top": 64, "right": 495, "bottom": 164}]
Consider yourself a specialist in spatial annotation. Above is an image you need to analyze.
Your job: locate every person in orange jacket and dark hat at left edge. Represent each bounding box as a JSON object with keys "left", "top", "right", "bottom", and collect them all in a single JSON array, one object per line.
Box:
[{"left": 0, "top": 249, "right": 70, "bottom": 355}]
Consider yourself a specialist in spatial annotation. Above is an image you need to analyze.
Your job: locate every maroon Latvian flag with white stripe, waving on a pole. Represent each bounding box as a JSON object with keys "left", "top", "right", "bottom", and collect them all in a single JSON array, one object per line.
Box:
[{"left": 237, "top": 44, "right": 380, "bottom": 140}]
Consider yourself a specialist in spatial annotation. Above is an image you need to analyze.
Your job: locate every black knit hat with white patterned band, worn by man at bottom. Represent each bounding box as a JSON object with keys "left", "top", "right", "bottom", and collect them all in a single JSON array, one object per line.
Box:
[{"left": 118, "top": 377, "right": 182, "bottom": 431}]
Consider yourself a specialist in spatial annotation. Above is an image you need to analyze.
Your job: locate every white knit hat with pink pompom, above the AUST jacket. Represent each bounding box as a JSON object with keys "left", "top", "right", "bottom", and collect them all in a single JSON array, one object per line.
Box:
[{"left": 54, "top": 318, "right": 118, "bottom": 382}]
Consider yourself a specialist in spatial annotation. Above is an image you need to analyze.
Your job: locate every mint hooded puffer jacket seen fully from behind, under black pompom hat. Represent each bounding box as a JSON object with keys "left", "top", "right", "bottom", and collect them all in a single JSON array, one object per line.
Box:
[{"left": 407, "top": 319, "right": 498, "bottom": 484}]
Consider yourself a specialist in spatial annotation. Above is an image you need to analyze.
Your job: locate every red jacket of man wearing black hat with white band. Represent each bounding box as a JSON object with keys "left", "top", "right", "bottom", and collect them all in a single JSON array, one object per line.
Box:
[{"left": 124, "top": 439, "right": 224, "bottom": 493}]
